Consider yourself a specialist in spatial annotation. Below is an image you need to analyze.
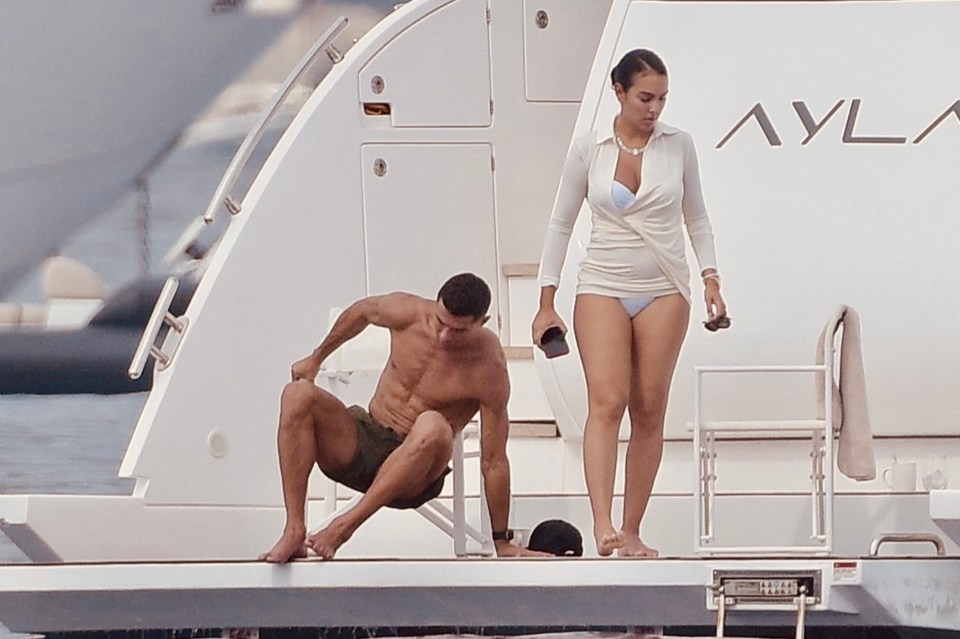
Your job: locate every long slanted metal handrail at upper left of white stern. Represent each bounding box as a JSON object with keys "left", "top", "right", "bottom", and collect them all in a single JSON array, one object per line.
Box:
[{"left": 203, "top": 16, "right": 349, "bottom": 224}]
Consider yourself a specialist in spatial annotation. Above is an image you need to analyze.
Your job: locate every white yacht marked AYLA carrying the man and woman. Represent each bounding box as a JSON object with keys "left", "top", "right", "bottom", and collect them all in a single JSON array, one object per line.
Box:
[{"left": 0, "top": 0, "right": 960, "bottom": 636}]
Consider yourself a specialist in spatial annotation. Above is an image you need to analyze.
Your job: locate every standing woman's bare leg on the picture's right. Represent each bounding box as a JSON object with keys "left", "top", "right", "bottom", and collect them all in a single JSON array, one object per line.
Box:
[{"left": 619, "top": 293, "right": 690, "bottom": 557}]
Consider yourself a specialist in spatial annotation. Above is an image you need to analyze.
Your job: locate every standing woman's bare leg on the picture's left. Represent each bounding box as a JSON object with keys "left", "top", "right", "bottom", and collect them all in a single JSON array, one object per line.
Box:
[{"left": 573, "top": 294, "right": 634, "bottom": 556}]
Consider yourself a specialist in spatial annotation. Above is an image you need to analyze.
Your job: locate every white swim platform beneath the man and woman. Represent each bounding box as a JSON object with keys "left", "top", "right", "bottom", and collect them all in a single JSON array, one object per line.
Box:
[{"left": 0, "top": 557, "right": 960, "bottom": 632}]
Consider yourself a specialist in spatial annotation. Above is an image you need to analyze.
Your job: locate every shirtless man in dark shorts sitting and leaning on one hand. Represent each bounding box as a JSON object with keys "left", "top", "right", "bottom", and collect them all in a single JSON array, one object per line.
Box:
[{"left": 260, "top": 273, "right": 545, "bottom": 563}]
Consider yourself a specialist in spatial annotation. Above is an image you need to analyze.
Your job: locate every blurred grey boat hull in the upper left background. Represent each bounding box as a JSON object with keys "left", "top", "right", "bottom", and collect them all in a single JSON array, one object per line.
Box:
[{"left": 0, "top": 0, "right": 301, "bottom": 299}]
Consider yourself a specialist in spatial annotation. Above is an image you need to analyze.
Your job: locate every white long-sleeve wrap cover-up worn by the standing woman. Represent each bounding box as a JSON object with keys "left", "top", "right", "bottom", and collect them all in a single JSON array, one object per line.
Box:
[{"left": 539, "top": 122, "right": 717, "bottom": 302}]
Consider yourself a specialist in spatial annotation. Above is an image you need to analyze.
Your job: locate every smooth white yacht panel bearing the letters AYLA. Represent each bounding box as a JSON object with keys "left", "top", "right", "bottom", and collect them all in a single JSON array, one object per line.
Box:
[{"left": 540, "top": 1, "right": 960, "bottom": 437}]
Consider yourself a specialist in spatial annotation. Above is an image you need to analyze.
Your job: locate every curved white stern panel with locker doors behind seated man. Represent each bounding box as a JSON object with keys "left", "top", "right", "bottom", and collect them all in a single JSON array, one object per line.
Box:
[{"left": 121, "top": 0, "right": 607, "bottom": 506}]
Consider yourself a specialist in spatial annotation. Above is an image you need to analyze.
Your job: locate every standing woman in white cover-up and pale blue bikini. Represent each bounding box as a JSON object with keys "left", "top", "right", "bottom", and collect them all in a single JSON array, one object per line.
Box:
[{"left": 533, "top": 49, "right": 729, "bottom": 557}]
